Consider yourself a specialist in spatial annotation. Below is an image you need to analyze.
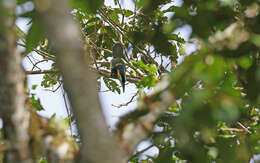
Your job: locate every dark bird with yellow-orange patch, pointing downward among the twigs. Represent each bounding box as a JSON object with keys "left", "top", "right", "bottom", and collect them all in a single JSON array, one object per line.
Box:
[{"left": 111, "top": 43, "right": 126, "bottom": 92}]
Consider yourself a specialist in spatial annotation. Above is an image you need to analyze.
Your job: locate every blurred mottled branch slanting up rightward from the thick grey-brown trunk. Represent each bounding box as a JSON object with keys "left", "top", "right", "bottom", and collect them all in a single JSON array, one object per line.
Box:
[{"left": 115, "top": 78, "right": 175, "bottom": 155}]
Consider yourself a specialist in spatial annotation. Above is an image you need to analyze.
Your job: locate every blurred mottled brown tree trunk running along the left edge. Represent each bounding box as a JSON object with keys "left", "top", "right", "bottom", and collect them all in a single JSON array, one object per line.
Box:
[{"left": 0, "top": 1, "right": 32, "bottom": 163}]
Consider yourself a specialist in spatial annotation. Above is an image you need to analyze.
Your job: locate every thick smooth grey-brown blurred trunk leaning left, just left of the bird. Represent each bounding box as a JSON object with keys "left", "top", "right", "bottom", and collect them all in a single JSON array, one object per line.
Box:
[{"left": 40, "top": 0, "right": 126, "bottom": 163}]
